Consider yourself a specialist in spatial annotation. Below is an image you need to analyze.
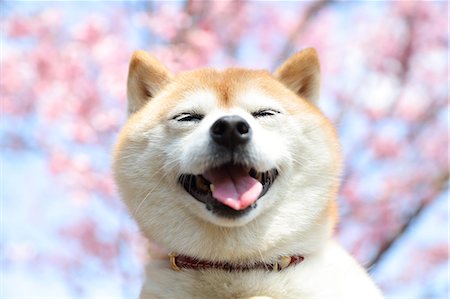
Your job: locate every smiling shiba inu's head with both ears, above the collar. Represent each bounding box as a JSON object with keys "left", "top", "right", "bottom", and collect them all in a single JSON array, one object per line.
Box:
[{"left": 114, "top": 50, "right": 341, "bottom": 256}]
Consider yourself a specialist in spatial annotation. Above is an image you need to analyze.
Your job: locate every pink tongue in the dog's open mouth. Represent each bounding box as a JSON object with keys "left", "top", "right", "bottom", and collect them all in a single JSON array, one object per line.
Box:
[{"left": 203, "top": 165, "right": 263, "bottom": 210}]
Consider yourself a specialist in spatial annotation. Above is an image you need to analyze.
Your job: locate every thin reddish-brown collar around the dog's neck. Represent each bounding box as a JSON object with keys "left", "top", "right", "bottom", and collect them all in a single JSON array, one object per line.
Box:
[{"left": 169, "top": 253, "right": 305, "bottom": 272}]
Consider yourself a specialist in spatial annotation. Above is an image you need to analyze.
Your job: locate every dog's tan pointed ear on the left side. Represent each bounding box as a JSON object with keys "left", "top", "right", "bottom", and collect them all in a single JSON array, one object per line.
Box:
[{"left": 127, "top": 51, "right": 172, "bottom": 115}]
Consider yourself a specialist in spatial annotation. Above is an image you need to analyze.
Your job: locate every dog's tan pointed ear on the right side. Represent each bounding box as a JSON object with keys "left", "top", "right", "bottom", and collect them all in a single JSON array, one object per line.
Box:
[{"left": 274, "top": 48, "right": 320, "bottom": 104}]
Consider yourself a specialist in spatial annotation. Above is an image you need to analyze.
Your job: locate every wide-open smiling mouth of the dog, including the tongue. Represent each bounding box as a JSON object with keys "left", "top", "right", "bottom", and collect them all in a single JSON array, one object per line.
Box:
[{"left": 178, "top": 164, "right": 278, "bottom": 218}]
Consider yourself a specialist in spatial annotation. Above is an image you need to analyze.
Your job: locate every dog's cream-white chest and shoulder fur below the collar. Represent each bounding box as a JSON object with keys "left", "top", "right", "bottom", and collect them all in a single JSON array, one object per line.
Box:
[{"left": 141, "top": 241, "right": 382, "bottom": 299}]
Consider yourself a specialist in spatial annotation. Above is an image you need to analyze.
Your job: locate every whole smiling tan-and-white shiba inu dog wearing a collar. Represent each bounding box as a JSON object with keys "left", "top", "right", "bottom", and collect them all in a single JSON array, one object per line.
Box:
[{"left": 114, "top": 49, "right": 382, "bottom": 299}]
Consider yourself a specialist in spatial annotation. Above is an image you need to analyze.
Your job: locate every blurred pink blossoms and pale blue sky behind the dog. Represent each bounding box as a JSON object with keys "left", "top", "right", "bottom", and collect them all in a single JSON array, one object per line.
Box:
[{"left": 0, "top": 1, "right": 449, "bottom": 298}]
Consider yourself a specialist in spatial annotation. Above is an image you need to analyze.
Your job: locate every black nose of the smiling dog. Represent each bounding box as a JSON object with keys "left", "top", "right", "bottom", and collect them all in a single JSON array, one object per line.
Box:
[{"left": 209, "top": 115, "right": 252, "bottom": 148}]
